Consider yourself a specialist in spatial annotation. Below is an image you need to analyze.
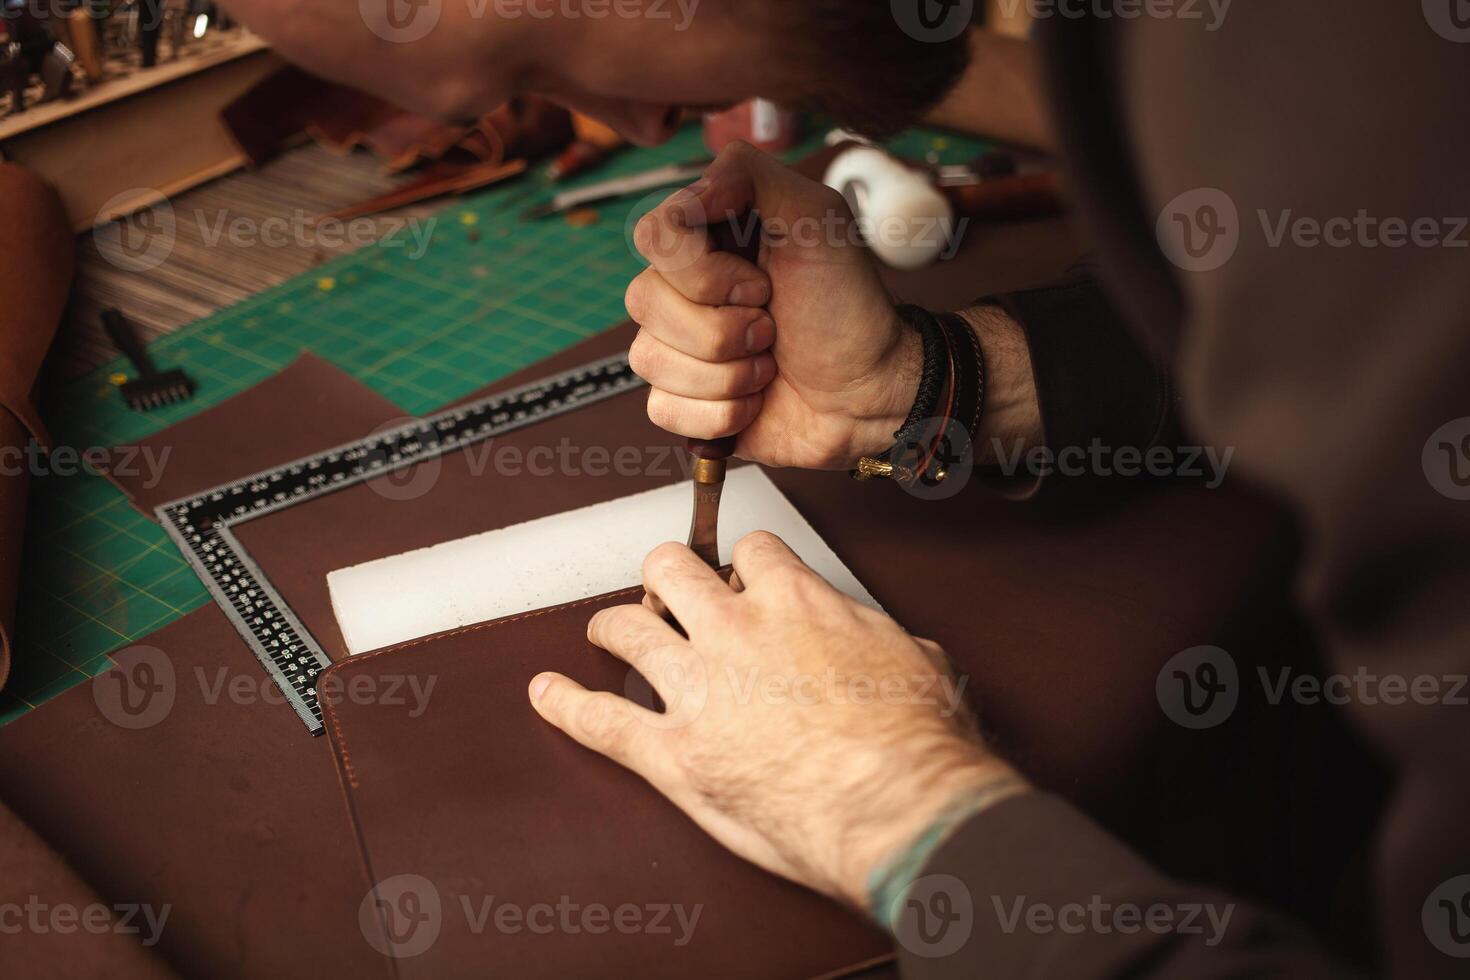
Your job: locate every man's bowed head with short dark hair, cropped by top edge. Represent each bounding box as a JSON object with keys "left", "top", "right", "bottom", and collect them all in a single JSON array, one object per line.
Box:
[{"left": 228, "top": 0, "right": 967, "bottom": 143}]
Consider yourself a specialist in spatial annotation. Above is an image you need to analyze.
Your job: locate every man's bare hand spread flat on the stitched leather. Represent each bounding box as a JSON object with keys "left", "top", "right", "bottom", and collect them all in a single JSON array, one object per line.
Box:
[{"left": 531, "top": 533, "right": 1016, "bottom": 907}]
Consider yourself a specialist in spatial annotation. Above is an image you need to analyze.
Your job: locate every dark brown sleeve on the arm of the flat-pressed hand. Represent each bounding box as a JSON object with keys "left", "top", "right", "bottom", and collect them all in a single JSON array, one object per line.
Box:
[{"left": 895, "top": 792, "right": 1352, "bottom": 980}]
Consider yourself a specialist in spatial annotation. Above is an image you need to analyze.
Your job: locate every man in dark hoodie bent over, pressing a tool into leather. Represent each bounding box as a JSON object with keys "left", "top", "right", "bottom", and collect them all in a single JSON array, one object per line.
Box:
[{"left": 220, "top": 0, "right": 1470, "bottom": 979}]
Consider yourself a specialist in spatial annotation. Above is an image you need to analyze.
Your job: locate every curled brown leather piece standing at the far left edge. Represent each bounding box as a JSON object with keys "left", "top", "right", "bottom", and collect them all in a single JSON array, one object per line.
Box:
[{"left": 0, "top": 163, "right": 72, "bottom": 688}]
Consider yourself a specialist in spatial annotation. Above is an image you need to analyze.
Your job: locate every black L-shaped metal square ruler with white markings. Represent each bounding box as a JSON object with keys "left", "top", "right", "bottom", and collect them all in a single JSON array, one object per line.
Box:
[{"left": 156, "top": 354, "right": 644, "bottom": 735}]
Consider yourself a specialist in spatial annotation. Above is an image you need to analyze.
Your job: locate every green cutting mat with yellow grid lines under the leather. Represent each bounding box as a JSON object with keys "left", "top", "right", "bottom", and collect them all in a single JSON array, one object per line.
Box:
[{"left": 0, "top": 128, "right": 985, "bottom": 724}]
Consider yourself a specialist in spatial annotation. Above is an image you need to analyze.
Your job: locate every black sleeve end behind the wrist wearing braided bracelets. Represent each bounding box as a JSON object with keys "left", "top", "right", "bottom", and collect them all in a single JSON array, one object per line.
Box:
[{"left": 978, "top": 263, "right": 1176, "bottom": 498}]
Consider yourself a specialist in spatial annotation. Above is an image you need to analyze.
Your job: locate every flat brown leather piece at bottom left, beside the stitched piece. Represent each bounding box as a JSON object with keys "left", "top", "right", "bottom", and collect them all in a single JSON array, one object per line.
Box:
[{"left": 0, "top": 605, "right": 384, "bottom": 979}]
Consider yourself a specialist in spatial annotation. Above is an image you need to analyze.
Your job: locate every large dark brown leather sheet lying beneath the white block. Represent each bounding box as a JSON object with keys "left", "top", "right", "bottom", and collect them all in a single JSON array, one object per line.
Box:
[{"left": 210, "top": 326, "right": 1304, "bottom": 899}]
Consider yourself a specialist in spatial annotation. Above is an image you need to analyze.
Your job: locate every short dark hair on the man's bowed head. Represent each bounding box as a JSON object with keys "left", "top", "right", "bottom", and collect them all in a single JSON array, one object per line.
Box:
[{"left": 776, "top": 0, "right": 980, "bottom": 138}]
